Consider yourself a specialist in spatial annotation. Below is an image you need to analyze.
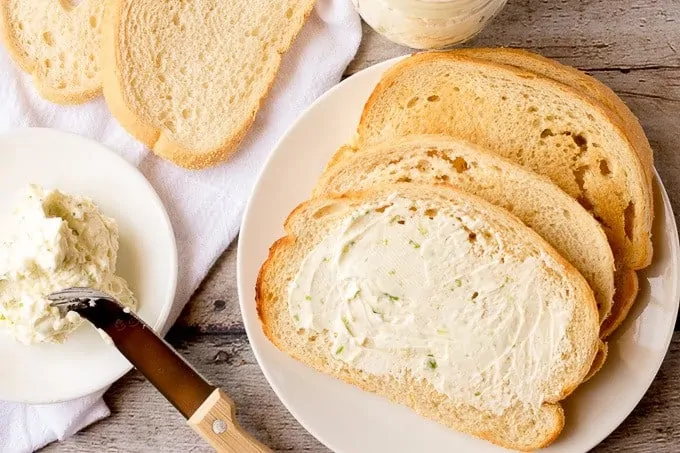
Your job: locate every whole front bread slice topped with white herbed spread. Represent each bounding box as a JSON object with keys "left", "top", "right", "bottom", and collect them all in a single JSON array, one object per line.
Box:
[{"left": 256, "top": 184, "right": 600, "bottom": 450}]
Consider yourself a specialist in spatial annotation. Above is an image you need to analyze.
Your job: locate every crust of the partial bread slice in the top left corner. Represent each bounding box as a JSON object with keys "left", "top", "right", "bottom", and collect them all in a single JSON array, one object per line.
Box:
[{"left": 0, "top": 1, "right": 102, "bottom": 105}]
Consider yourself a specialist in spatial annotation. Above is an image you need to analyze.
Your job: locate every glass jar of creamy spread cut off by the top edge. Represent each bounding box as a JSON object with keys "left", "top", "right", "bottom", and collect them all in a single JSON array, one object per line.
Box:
[{"left": 352, "top": 0, "right": 506, "bottom": 49}]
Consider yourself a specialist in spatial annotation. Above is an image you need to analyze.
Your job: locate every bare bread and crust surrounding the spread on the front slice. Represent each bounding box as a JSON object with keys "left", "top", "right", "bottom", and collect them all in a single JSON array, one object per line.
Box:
[{"left": 256, "top": 184, "right": 600, "bottom": 451}]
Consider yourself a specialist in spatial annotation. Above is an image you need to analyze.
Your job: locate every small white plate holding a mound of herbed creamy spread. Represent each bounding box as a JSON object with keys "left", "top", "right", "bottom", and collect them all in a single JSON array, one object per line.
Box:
[{"left": 0, "top": 129, "right": 177, "bottom": 404}]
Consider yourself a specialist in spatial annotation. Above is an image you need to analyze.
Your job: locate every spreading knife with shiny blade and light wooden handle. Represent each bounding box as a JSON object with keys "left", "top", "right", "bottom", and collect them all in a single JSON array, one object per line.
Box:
[{"left": 48, "top": 288, "right": 271, "bottom": 453}]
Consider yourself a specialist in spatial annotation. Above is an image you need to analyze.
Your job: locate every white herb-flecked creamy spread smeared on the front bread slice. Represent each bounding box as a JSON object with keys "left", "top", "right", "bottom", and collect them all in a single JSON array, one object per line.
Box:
[{"left": 288, "top": 196, "right": 572, "bottom": 414}]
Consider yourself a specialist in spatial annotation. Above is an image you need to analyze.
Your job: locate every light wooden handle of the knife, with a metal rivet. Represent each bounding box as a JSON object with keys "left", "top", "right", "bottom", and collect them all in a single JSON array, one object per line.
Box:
[{"left": 189, "top": 389, "right": 271, "bottom": 453}]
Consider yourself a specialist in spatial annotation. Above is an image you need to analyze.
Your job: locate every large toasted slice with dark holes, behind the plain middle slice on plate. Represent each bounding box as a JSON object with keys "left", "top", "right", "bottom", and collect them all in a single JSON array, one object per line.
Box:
[{"left": 358, "top": 53, "right": 653, "bottom": 269}]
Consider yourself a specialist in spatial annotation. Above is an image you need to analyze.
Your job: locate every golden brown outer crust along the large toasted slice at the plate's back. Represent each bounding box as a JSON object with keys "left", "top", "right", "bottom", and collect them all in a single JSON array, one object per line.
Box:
[{"left": 357, "top": 52, "right": 654, "bottom": 269}]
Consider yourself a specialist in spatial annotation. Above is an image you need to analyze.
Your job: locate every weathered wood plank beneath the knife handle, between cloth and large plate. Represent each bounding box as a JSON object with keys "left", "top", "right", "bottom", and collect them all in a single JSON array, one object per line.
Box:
[{"left": 44, "top": 329, "right": 325, "bottom": 453}]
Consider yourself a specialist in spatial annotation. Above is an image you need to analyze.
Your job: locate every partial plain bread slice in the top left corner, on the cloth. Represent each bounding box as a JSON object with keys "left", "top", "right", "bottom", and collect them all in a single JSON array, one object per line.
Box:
[{"left": 0, "top": 0, "right": 104, "bottom": 104}]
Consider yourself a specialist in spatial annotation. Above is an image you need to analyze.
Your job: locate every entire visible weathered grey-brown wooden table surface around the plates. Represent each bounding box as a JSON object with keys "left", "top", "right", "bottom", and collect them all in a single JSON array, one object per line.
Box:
[{"left": 43, "top": 0, "right": 680, "bottom": 453}]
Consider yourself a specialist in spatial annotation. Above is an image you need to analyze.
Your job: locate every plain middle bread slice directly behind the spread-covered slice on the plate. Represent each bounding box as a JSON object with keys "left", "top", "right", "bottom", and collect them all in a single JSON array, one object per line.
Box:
[{"left": 314, "top": 135, "right": 614, "bottom": 323}]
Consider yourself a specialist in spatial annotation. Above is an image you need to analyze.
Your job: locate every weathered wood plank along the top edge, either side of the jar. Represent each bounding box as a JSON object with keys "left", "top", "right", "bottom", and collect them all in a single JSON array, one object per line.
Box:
[{"left": 347, "top": 0, "right": 680, "bottom": 74}]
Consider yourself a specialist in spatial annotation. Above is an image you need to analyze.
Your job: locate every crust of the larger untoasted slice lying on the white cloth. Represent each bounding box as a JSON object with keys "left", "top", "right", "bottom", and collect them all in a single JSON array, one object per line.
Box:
[{"left": 102, "top": 0, "right": 315, "bottom": 170}]
